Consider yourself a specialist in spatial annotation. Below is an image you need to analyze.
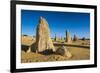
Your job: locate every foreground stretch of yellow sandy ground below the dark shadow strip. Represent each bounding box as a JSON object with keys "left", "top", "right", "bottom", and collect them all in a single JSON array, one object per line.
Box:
[{"left": 21, "top": 47, "right": 90, "bottom": 63}]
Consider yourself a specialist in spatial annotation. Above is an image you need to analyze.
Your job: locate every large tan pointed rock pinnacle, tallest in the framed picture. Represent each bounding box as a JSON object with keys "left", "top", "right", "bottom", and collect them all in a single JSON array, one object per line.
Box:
[{"left": 36, "top": 17, "right": 55, "bottom": 52}]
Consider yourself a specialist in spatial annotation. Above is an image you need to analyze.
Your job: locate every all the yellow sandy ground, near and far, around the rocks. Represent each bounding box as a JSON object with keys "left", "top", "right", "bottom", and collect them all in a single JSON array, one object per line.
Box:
[{"left": 21, "top": 36, "right": 90, "bottom": 63}]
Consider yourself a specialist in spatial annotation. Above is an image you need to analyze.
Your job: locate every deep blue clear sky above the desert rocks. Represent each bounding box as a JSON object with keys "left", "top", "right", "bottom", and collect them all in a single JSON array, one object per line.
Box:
[{"left": 21, "top": 10, "right": 90, "bottom": 38}]
